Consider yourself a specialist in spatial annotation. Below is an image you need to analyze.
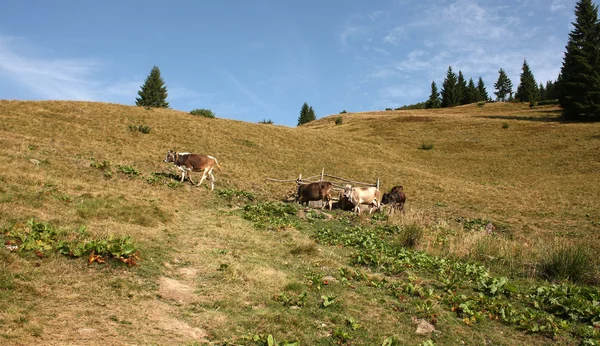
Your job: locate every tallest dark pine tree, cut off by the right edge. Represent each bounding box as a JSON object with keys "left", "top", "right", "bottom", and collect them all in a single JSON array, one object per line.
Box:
[{"left": 557, "top": 0, "right": 600, "bottom": 118}]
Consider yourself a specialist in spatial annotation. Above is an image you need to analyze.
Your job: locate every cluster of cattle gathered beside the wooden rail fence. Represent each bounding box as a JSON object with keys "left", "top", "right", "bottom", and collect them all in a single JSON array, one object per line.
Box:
[{"left": 296, "top": 181, "right": 406, "bottom": 214}]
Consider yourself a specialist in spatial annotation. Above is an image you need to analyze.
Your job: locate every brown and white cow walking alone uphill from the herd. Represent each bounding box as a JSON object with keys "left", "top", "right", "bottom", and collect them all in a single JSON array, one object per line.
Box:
[{"left": 163, "top": 150, "right": 221, "bottom": 191}]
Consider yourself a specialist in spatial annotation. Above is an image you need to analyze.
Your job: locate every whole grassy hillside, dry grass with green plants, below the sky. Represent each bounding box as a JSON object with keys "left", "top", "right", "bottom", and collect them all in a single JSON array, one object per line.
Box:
[{"left": 0, "top": 101, "right": 600, "bottom": 345}]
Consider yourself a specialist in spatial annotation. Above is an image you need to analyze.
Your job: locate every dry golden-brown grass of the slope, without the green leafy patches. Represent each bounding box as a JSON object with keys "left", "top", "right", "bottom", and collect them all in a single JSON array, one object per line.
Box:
[{"left": 0, "top": 101, "right": 600, "bottom": 344}]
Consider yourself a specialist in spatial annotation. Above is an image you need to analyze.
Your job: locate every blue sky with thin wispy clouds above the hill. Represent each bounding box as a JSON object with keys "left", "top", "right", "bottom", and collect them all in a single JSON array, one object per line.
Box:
[{"left": 0, "top": 0, "right": 576, "bottom": 126}]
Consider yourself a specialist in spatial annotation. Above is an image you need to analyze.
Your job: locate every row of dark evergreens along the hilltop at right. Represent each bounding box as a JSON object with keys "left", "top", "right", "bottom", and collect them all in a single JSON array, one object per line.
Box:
[{"left": 425, "top": 0, "right": 600, "bottom": 119}]
